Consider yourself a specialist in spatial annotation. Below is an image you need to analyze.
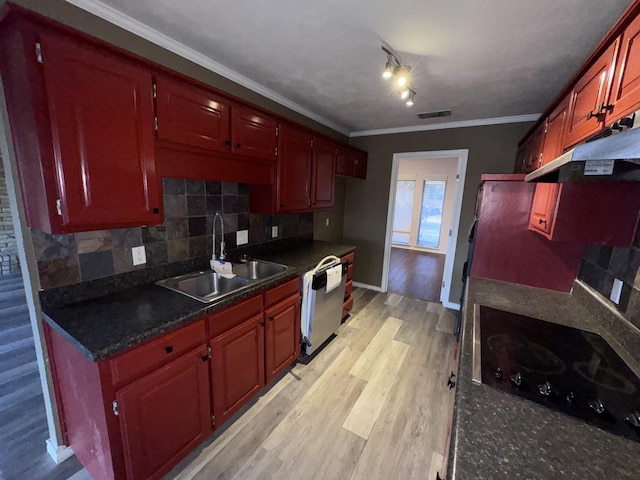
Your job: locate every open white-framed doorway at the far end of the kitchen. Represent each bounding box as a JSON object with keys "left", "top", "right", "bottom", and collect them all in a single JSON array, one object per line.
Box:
[{"left": 382, "top": 150, "right": 468, "bottom": 309}]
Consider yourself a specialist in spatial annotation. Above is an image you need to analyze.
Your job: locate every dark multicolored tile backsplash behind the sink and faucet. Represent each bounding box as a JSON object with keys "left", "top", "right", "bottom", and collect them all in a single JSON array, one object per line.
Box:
[{"left": 31, "top": 178, "right": 313, "bottom": 290}]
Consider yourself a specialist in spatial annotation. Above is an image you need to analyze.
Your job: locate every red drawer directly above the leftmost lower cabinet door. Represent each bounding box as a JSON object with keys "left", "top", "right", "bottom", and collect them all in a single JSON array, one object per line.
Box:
[{"left": 110, "top": 319, "right": 206, "bottom": 386}]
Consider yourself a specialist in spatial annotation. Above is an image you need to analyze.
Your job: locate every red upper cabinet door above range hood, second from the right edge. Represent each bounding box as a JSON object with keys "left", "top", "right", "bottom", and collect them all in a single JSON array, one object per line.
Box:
[{"left": 564, "top": 41, "right": 618, "bottom": 147}]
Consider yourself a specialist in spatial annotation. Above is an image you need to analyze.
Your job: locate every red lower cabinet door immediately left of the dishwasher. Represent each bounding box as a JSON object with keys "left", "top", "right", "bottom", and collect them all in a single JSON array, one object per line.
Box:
[{"left": 264, "top": 294, "right": 300, "bottom": 382}]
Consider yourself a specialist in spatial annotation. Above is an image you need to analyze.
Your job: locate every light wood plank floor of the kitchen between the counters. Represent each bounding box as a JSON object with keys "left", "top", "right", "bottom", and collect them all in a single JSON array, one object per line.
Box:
[{"left": 167, "top": 289, "right": 456, "bottom": 480}]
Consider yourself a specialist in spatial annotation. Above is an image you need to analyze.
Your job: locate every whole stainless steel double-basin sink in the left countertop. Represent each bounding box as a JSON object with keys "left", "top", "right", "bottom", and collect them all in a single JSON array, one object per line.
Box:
[{"left": 156, "top": 260, "right": 288, "bottom": 303}]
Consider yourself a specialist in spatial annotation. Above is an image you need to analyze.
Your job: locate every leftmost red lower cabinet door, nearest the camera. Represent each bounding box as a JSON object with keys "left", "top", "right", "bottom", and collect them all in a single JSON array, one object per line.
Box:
[{"left": 116, "top": 346, "right": 211, "bottom": 480}]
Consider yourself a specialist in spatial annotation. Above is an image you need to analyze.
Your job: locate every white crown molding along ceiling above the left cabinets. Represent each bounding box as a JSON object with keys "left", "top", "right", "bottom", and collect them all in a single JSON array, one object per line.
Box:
[{"left": 66, "top": 0, "right": 349, "bottom": 135}]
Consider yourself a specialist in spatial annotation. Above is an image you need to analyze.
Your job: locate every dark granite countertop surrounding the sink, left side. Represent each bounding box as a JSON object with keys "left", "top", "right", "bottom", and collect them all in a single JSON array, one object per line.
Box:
[{"left": 42, "top": 241, "right": 355, "bottom": 361}]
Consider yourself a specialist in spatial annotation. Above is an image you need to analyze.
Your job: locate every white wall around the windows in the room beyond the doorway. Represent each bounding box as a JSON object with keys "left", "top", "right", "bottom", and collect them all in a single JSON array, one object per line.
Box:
[{"left": 398, "top": 158, "right": 458, "bottom": 254}]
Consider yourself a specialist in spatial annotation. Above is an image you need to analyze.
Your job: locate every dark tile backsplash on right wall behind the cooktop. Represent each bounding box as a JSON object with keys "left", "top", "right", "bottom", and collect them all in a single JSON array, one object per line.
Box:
[{"left": 578, "top": 222, "right": 640, "bottom": 328}]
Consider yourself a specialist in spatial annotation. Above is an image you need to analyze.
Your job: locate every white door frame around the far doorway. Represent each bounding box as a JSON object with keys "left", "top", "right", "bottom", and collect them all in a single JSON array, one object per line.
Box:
[{"left": 382, "top": 149, "right": 469, "bottom": 310}]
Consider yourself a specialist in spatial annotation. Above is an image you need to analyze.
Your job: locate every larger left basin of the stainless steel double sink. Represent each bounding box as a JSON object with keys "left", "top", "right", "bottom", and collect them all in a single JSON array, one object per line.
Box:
[{"left": 156, "top": 272, "right": 249, "bottom": 302}]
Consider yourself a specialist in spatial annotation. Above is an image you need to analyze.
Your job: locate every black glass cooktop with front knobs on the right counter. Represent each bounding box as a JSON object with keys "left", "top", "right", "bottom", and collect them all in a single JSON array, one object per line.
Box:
[{"left": 480, "top": 307, "right": 640, "bottom": 441}]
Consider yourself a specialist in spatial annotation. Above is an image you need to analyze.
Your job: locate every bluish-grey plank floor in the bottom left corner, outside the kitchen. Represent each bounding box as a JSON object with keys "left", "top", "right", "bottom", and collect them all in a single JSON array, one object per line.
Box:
[{"left": 0, "top": 275, "right": 87, "bottom": 480}]
